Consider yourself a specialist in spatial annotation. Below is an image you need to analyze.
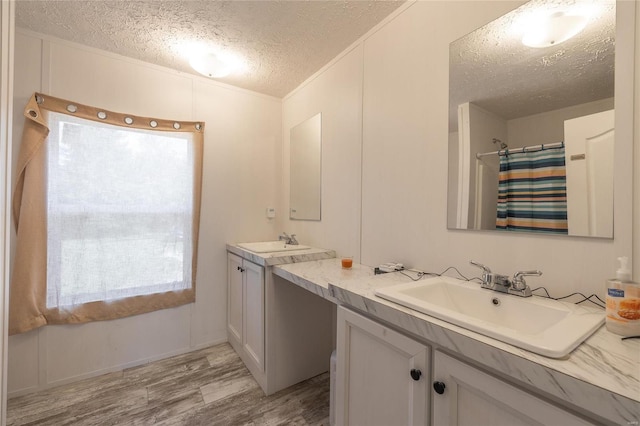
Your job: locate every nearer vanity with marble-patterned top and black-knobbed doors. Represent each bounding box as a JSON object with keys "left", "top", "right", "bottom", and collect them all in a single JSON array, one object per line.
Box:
[{"left": 273, "top": 259, "right": 640, "bottom": 425}]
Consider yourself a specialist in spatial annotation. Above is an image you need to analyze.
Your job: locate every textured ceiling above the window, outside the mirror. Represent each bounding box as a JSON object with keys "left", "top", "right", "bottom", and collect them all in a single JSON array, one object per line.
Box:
[{"left": 16, "top": 0, "right": 403, "bottom": 97}]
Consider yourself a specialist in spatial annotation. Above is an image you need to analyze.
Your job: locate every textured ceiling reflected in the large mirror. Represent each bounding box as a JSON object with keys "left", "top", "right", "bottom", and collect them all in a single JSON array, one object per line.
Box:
[{"left": 449, "top": 0, "right": 616, "bottom": 131}]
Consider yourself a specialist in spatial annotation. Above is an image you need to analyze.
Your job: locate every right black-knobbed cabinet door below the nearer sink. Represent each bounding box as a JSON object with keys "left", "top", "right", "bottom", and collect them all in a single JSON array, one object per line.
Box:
[{"left": 432, "top": 351, "right": 591, "bottom": 426}]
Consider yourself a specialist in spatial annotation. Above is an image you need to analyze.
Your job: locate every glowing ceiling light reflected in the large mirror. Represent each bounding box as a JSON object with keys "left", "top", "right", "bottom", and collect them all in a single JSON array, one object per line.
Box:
[{"left": 522, "top": 11, "right": 589, "bottom": 48}]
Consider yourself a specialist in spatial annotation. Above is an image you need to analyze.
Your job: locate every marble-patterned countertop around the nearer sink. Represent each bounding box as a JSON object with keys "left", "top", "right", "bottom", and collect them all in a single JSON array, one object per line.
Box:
[{"left": 274, "top": 259, "right": 640, "bottom": 424}]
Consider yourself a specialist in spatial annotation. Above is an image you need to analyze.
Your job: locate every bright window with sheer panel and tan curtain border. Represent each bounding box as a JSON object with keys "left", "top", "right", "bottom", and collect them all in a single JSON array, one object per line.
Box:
[{"left": 9, "top": 94, "right": 204, "bottom": 334}]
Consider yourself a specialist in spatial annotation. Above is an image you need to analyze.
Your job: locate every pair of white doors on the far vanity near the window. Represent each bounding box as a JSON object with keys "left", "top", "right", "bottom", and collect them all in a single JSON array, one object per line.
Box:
[{"left": 227, "top": 253, "right": 265, "bottom": 371}]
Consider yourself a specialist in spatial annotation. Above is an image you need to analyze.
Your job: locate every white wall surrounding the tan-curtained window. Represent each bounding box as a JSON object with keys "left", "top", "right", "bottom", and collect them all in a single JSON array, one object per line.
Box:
[{"left": 8, "top": 31, "right": 282, "bottom": 395}]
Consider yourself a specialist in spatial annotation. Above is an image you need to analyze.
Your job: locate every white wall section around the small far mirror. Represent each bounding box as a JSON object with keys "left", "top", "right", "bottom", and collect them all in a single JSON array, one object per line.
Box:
[{"left": 279, "top": 46, "right": 363, "bottom": 261}]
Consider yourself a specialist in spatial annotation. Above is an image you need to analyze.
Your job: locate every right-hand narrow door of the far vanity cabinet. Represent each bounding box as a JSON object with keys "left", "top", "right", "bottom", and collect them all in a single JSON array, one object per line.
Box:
[{"left": 243, "top": 261, "right": 264, "bottom": 371}]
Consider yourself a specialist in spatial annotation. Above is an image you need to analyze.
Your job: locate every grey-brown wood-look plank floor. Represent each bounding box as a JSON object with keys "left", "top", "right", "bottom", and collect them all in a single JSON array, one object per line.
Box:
[{"left": 7, "top": 343, "right": 329, "bottom": 426}]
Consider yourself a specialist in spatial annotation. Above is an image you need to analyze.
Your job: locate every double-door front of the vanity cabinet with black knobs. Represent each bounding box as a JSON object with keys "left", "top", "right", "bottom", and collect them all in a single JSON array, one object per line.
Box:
[{"left": 335, "top": 306, "right": 596, "bottom": 426}]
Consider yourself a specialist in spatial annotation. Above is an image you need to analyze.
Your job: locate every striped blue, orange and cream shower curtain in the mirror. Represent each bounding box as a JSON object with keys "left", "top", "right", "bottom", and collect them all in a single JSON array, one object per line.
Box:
[{"left": 496, "top": 146, "right": 567, "bottom": 234}]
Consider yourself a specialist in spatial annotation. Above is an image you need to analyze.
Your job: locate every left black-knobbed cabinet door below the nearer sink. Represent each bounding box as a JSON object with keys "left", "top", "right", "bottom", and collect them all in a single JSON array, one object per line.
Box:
[{"left": 336, "top": 307, "right": 430, "bottom": 426}]
